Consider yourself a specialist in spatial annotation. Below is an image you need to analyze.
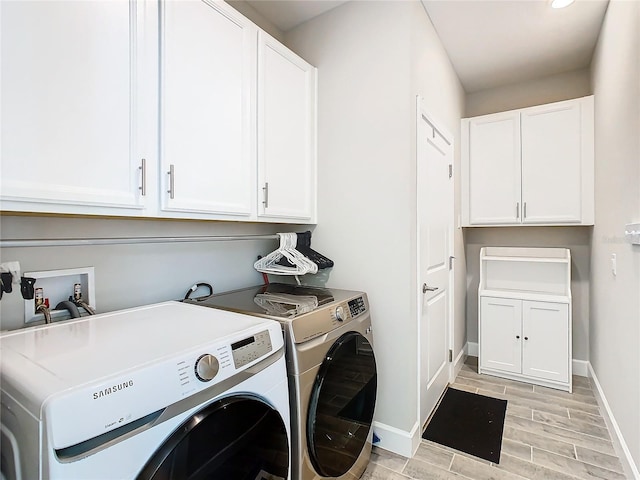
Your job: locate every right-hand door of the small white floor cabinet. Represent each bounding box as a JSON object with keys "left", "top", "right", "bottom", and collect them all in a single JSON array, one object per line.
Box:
[{"left": 522, "top": 301, "right": 571, "bottom": 382}]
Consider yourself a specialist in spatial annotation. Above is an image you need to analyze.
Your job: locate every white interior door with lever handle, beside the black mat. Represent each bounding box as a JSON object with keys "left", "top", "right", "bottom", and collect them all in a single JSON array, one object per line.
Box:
[{"left": 416, "top": 99, "right": 454, "bottom": 426}]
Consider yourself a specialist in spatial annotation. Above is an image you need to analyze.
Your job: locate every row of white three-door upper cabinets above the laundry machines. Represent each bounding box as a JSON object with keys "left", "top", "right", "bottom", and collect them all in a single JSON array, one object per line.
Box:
[{"left": 0, "top": 1, "right": 317, "bottom": 223}]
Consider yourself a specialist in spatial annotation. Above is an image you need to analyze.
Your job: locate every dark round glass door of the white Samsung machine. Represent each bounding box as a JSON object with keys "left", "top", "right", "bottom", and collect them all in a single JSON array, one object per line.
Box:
[{"left": 137, "top": 395, "right": 289, "bottom": 480}]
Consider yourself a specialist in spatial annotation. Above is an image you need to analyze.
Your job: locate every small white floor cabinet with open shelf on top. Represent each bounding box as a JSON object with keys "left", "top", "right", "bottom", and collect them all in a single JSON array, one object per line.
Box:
[{"left": 478, "top": 247, "right": 572, "bottom": 392}]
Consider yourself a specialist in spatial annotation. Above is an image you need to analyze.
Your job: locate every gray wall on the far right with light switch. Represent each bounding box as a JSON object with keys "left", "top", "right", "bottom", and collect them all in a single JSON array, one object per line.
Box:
[{"left": 590, "top": 0, "right": 640, "bottom": 472}]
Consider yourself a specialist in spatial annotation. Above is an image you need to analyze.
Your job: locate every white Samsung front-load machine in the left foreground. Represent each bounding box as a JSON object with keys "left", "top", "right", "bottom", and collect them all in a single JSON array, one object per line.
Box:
[{"left": 0, "top": 302, "right": 290, "bottom": 480}]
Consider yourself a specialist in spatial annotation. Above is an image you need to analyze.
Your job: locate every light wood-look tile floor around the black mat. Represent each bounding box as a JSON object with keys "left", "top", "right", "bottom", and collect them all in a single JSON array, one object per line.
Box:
[{"left": 362, "top": 357, "right": 627, "bottom": 480}]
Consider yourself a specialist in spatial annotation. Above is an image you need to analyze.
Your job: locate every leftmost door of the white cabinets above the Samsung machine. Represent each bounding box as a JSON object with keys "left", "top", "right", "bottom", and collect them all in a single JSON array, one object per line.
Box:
[{"left": 0, "top": 0, "right": 149, "bottom": 214}]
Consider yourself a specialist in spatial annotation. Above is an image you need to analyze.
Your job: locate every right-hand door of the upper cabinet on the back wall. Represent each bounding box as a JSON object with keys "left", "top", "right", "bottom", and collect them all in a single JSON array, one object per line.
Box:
[{"left": 522, "top": 101, "right": 583, "bottom": 223}]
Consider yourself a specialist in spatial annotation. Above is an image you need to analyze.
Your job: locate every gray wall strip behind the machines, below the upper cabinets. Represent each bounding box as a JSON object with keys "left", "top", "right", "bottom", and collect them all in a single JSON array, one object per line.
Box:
[{"left": 0, "top": 216, "right": 290, "bottom": 335}]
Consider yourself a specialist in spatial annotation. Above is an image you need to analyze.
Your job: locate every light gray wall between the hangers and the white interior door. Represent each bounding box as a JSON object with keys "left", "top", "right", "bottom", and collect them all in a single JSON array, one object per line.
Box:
[{"left": 285, "top": 1, "right": 464, "bottom": 444}]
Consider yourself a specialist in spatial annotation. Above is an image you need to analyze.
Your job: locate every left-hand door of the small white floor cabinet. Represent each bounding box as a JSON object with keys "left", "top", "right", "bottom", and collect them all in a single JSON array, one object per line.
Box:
[{"left": 479, "top": 297, "right": 522, "bottom": 373}]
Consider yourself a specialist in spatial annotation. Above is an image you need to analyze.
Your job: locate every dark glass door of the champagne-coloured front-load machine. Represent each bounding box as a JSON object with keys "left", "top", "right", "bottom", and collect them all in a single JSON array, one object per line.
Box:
[{"left": 307, "top": 332, "right": 377, "bottom": 477}]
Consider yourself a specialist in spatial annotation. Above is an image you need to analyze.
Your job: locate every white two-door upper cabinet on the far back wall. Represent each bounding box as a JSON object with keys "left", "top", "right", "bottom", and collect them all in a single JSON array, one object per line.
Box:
[{"left": 462, "top": 97, "right": 594, "bottom": 226}]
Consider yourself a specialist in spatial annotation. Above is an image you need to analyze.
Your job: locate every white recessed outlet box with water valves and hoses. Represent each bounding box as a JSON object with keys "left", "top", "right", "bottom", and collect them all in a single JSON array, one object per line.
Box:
[{"left": 24, "top": 267, "right": 96, "bottom": 323}]
